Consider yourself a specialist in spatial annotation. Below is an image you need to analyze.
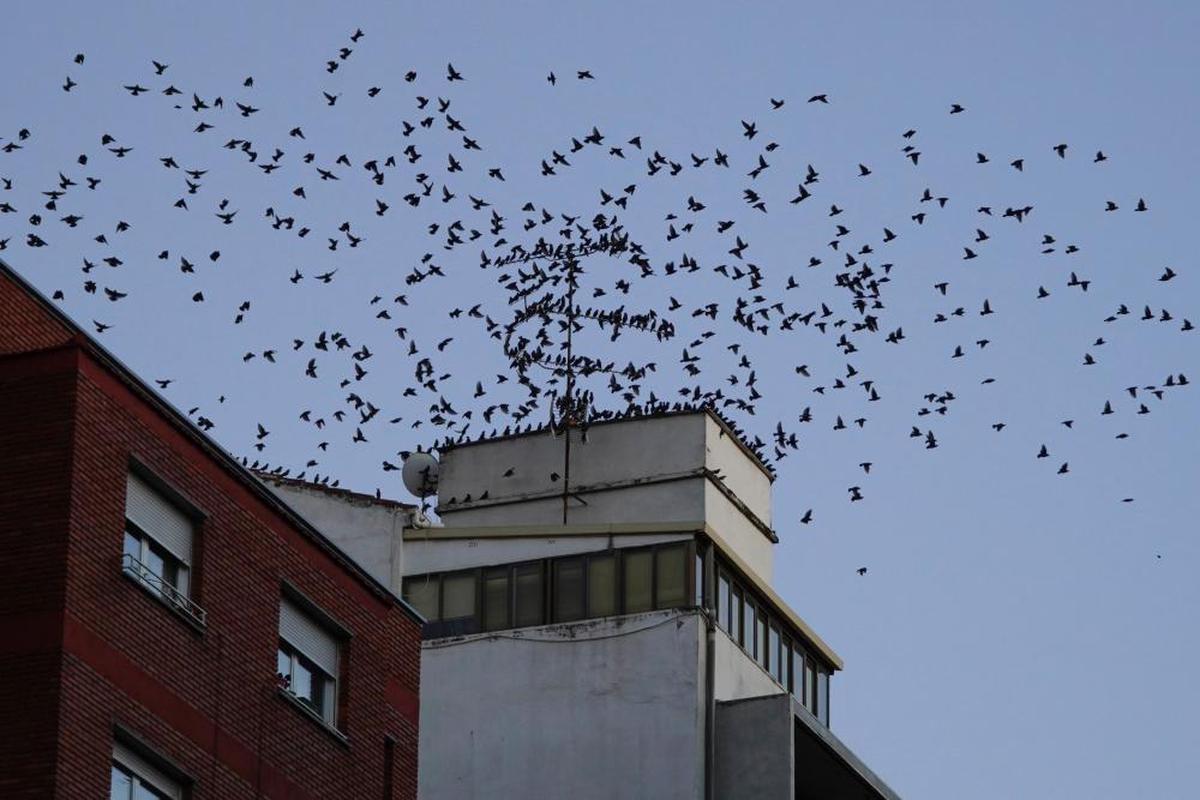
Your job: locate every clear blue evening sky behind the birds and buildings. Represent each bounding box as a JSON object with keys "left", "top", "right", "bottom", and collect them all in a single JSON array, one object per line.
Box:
[{"left": 0, "top": 2, "right": 1200, "bottom": 799}]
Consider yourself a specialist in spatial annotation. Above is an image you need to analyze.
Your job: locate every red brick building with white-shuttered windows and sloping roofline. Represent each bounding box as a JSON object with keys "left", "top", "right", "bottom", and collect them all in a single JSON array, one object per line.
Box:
[{"left": 0, "top": 261, "right": 421, "bottom": 800}]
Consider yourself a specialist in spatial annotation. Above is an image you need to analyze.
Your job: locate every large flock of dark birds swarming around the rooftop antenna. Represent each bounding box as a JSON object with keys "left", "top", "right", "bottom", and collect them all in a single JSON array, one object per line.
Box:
[{"left": 0, "top": 30, "right": 1194, "bottom": 575}]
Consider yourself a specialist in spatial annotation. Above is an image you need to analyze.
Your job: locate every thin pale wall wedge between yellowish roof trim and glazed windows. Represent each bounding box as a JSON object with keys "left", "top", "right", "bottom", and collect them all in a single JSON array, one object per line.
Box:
[{"left": 404, "top": 529, "right": 692, "bottom": 575}]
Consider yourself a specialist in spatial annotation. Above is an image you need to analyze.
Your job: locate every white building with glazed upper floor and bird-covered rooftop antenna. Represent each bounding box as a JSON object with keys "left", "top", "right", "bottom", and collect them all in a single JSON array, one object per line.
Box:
[{"left": 262, "top": 411, "right": 896, "bottom": 800}]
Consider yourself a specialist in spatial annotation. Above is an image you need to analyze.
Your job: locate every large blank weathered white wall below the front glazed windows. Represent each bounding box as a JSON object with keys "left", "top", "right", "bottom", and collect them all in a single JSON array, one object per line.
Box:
[{"left": 419, "top": 610, "right": 704, "bottom": 800}]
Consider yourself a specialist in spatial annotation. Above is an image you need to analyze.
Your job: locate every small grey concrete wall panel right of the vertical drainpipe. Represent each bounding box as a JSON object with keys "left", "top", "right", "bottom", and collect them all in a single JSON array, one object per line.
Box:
[{"left": 716, "top": 697, "right": 796, "bottom": 800}]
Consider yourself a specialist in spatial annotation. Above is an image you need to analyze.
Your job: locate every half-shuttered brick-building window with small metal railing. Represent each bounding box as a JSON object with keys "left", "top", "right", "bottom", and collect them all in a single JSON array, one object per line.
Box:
[{"left": 121, "top": 473, "right": 204, "bottom": 622}]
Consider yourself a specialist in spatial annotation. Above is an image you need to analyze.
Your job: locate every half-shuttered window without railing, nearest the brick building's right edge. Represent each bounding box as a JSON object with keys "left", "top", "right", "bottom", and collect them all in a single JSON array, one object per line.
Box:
[{"left": 276, "top": 597, "right": 341, "bottom": 726}]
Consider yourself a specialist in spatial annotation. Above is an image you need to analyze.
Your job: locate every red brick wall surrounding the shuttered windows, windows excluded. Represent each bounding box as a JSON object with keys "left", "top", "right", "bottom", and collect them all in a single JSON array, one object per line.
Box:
[{"left": 0, "top": 271, "right": 420, "bottom": 800}]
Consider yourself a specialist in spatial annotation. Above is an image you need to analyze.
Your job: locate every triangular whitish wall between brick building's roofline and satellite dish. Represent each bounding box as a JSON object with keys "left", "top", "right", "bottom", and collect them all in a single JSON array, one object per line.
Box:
[{"left": 264, "top": 480, "right": 409, "bottom": 594}]
